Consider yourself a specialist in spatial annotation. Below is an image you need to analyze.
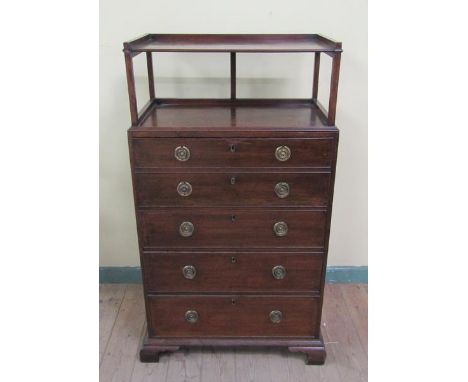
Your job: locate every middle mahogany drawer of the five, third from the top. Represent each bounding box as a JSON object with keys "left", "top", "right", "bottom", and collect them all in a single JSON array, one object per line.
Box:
[{"left": 137, "top": 208, "right": 326, "bottom": 249}]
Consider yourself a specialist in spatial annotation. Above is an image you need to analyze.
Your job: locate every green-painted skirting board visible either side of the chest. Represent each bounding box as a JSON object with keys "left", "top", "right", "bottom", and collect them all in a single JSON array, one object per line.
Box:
[{"left": 99, "top": 266, "right": 367, "bottom": 284}]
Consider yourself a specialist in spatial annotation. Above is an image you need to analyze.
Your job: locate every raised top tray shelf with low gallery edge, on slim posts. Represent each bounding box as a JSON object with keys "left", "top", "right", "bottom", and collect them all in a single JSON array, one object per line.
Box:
[{"left": 124, "top": 34, "right": 342, "bottom": 53}]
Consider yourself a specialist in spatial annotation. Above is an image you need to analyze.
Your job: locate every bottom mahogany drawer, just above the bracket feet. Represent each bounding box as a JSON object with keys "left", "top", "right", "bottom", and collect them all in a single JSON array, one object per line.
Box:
[{"left": 147, "top": 295, "right": 319, "bottom": 337}]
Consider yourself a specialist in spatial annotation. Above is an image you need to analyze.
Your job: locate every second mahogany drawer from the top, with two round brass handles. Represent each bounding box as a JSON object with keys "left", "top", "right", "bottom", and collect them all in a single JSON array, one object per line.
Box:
[{"left": 135, "top": 171, "right": 330, "bottom": 207}]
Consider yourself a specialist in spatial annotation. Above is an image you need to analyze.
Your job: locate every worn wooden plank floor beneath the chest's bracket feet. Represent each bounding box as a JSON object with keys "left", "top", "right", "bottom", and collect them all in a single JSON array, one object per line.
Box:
[{"left": 99, "top": 284, "right": 367, "bottom": 382}]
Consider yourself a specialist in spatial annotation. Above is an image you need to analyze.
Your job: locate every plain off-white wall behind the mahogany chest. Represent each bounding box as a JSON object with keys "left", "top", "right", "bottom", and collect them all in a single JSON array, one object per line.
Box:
[{"left": 100, "top": 0, "right": 367, "bottom": 266}]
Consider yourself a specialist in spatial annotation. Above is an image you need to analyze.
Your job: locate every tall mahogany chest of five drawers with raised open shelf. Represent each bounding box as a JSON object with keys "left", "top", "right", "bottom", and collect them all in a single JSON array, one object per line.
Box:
[{"left": 124, "top": 35, "right": 341, "bottom": 364}]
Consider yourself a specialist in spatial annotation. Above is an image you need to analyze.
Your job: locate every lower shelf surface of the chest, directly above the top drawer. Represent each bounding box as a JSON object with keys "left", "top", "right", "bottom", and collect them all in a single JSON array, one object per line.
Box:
[{"left": 130, "top": 99, "right": 336, "bottom": 134}]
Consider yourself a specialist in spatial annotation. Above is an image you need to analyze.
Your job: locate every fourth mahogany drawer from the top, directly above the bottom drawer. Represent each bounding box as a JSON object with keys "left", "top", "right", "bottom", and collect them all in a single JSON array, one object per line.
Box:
[{"left": 143, "top": 252, "right": 323, "bottom": 293}]
